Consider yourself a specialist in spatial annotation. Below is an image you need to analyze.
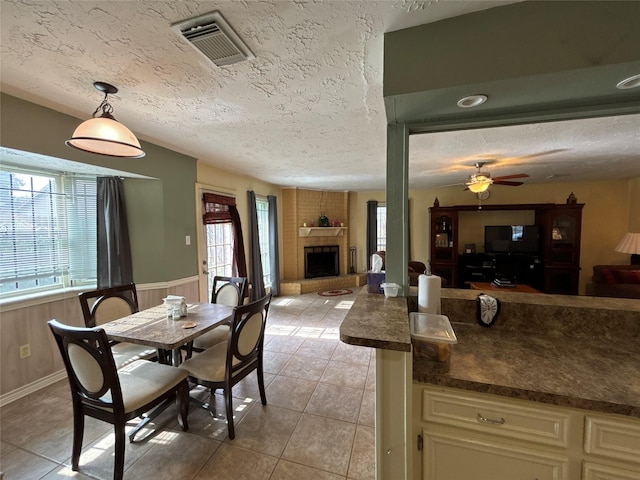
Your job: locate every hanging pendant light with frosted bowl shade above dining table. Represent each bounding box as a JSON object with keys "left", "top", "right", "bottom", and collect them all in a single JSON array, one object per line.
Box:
[{"left": 65, "top": 82, "right": 145, "bottom": 158}]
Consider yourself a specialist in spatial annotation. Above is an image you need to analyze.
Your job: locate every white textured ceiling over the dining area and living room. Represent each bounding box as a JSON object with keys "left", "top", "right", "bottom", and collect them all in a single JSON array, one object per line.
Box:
[{"left": 0, "top": 0, "right": 640, "bottom": 190}]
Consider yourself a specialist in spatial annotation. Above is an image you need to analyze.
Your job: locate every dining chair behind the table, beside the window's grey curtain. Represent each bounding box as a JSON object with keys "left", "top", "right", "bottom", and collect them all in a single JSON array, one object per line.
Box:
[{"left": 78, "top": 283, "right": 159, "bottom": 368}]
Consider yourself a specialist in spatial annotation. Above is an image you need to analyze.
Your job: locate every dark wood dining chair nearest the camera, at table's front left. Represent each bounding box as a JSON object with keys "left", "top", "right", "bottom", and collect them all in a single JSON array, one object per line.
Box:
[{"left": 48, "top": 320, "right": 189, "bottom": 480}]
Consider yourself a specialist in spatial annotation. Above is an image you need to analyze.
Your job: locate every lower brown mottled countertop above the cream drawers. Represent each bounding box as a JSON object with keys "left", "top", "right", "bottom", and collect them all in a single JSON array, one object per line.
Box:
[{"left": 413, "top": 323, "right": 640, "bottom": 417}]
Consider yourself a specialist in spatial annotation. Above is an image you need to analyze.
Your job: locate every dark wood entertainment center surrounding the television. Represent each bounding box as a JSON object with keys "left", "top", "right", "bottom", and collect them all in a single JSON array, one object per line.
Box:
[{"left": 429, "top": 203, "right": 584, "bottom": 295}]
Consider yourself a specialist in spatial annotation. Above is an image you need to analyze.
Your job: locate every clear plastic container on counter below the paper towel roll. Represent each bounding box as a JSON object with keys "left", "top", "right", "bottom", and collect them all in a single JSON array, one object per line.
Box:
[{"left": 409, "top": 312, "right": 458, "bottom": 373}]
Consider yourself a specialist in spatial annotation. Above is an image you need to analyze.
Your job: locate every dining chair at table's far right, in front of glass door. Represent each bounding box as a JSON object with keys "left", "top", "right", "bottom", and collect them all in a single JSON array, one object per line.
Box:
[{"left": 187, "top": 276, "right": 247, "bottom": 358}]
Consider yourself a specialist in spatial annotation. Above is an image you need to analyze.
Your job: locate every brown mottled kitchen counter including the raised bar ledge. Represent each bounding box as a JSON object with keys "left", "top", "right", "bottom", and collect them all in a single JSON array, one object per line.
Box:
[{"left": 340, "top": 287, "right": 640, "bottom": 417}]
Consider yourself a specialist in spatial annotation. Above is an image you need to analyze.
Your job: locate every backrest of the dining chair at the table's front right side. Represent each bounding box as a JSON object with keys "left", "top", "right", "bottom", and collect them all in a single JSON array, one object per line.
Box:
[{"left": 227, "top": 294, "right": 271, "bottom": 376}]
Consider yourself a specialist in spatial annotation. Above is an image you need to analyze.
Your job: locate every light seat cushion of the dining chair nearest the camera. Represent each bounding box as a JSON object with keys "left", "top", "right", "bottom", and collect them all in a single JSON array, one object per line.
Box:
[{"left": 105, "top": 360, "right": 187, "bottom": 413}]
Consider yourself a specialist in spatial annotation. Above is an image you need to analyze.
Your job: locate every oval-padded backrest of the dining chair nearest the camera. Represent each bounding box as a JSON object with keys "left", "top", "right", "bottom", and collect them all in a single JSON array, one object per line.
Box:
[{"left": 47, "top": 320, "right": 124, "bottom": 414}]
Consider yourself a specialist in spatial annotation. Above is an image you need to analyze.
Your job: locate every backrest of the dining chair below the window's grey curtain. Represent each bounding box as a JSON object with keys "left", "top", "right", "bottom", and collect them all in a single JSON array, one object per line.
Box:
[{"left": 78, "top": 283, "right": 138, "bottom": 328}]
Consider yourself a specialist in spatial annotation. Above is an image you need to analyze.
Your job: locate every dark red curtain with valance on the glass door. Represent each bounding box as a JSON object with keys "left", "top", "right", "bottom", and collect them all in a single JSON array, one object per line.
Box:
[{"left": 202, "top": 193, "right": 247, "bottom": 277}]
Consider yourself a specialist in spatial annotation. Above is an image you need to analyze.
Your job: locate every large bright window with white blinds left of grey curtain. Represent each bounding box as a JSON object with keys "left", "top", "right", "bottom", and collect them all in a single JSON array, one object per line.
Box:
[{"left": 0, "top": 166, "right": 97, "bottom": 297}]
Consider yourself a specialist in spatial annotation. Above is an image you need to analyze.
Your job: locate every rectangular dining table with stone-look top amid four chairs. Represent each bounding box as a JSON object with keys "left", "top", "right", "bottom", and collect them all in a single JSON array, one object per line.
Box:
[{"left": 100, "top": 303, "right": 233, "bottom": 441}]
